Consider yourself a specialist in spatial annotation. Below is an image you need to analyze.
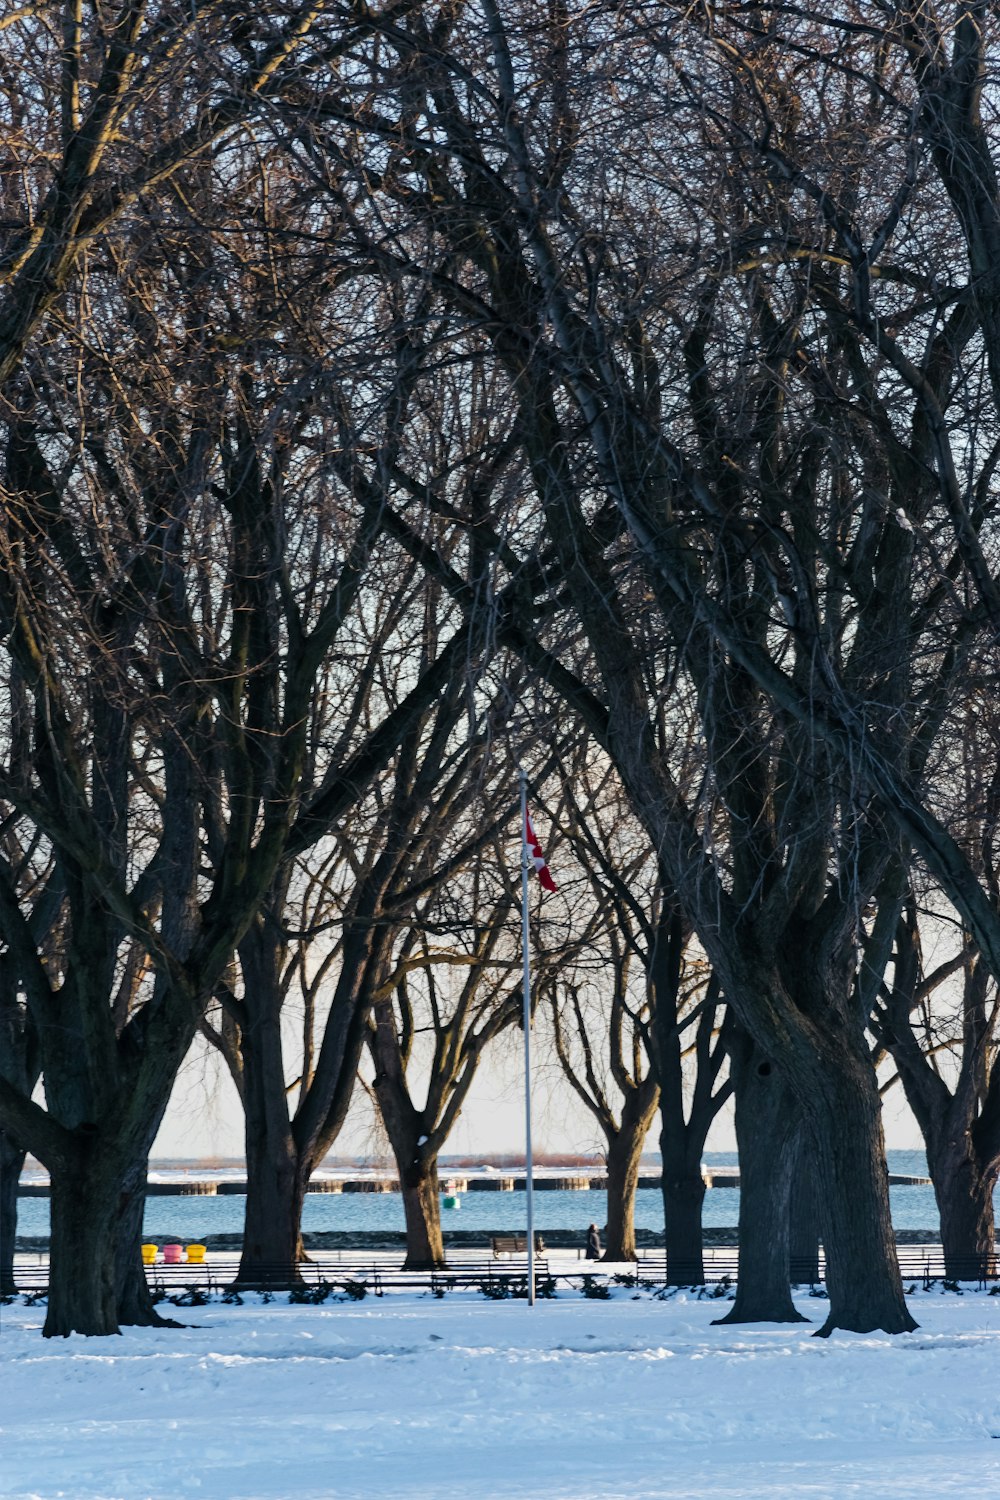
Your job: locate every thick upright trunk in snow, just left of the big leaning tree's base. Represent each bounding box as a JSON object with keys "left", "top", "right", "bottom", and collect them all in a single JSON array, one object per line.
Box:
[{"left": 717, "top": 1034, "right": 807, "bottom": 1323}]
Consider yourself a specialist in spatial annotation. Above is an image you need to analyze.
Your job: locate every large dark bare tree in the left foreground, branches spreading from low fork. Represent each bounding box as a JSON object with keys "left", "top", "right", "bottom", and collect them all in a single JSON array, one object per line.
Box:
[{"left": 0, "top": 123, "right": 465, "bottom": 1334}]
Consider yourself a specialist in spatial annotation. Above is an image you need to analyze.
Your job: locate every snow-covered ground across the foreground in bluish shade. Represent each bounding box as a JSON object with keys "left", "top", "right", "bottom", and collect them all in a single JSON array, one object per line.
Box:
[{"left": 0, "top": 1289, "right": 1000, "bottom": 1500}]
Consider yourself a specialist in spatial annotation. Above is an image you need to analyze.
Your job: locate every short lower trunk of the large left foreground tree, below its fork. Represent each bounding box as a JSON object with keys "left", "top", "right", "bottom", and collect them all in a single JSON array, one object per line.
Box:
[{"left": 42, "top": 1161, "right": 118, "bottom": 1338}]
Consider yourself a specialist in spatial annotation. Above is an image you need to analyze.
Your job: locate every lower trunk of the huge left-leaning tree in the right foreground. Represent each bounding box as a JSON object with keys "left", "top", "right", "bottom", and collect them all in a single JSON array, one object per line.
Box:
[{"left": 801, "top": 1043, "right": 916, "bottom": 1335}]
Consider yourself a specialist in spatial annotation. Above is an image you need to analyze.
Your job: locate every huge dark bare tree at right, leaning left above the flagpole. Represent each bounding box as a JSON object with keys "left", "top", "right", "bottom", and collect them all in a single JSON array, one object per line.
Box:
[{"left": 305, "top": 0, "right": 912, "bottom": 1329}]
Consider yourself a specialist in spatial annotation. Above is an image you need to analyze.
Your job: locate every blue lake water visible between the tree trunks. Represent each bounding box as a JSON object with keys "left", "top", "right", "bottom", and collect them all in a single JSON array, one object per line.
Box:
[{"left": 18, "top": 1151, "right": 983, "bottom": 1244}]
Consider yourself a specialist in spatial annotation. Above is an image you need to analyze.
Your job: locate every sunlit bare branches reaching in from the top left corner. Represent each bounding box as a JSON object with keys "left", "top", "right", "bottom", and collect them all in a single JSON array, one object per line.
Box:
[{"left": 0, "top": 0, "right": 394, "bottom": 393}]
